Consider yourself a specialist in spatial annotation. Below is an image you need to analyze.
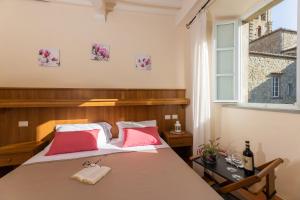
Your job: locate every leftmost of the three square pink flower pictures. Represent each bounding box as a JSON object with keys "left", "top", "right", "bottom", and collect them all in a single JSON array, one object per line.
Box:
[{"left": 38, "top": 48, "right": 60, "bottom": 67}]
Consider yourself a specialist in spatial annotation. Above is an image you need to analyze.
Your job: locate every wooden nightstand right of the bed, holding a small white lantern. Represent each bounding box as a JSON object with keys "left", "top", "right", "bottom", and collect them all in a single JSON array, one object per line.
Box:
[{"left": 162, "top": 131, "right": 193, "bottom": 165}]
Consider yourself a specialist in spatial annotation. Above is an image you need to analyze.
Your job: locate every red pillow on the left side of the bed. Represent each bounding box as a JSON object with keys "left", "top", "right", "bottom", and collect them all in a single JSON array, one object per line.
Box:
[{"left": 46, "top": 129, "right": 99, "bottom": 156}]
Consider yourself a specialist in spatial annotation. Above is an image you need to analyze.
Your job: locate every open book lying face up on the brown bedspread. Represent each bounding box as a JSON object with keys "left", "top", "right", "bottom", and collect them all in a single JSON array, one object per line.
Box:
[{"left": 71, "top": 165, "right": 111, "bottom": 185}]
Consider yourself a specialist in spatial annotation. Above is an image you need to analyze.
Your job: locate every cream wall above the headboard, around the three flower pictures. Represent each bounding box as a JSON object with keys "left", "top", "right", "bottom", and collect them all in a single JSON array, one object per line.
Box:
[{"left": 0, "top": 0, "right": 185, "bottom": 88}]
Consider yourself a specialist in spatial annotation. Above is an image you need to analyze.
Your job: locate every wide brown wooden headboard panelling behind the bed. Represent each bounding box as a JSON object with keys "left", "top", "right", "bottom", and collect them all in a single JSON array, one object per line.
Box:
[{"left": 0, "top": 88, "right": 189, "bottom": 146}]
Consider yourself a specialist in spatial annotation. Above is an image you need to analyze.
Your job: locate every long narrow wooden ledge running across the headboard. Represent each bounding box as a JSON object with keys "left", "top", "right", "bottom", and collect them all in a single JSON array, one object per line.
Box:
[{"left": 0, "top": 98, "right": 189, "bottom": 108}]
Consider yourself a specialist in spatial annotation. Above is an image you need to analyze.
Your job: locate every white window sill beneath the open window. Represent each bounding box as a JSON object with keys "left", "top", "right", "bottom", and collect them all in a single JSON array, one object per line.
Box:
[{"left": 223, "top": 103, "right": 300, "bottom": 114}]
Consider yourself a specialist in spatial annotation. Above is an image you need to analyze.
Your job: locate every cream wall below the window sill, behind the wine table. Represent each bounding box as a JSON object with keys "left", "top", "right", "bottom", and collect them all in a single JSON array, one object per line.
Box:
[{"left": 217, "top": 107, "right": 300, "bottom": 200}]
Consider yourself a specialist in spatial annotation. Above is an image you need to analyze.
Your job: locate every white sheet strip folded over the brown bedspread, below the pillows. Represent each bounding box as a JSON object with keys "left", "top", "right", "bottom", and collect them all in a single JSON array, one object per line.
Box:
[{"left": 23, "top": 138, "right": 170, "bottom": 165}]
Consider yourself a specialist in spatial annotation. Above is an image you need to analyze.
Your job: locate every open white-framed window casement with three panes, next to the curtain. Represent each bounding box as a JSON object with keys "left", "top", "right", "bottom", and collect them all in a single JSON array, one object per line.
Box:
[{"left": 214, "top": 22, "right": 238, "bottom": 102}]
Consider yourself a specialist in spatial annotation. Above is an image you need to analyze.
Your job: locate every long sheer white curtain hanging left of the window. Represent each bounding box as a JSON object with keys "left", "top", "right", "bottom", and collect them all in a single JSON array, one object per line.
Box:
[{"left": 190, "top": 11, "right": 211, "bottom": 154}]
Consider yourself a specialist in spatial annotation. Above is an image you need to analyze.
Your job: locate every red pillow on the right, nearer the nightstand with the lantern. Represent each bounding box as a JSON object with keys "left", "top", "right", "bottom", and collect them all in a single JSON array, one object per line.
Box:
[{"left": 123, "top": 127, "right": 161, "bottom": 147}]
